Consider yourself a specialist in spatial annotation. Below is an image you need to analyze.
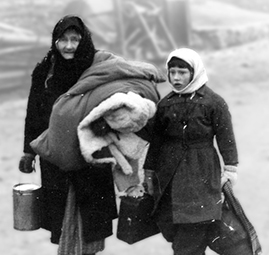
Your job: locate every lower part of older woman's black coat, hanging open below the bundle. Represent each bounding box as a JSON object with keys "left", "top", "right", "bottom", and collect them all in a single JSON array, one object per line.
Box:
[{"left": 41, "top": 159, "right": 117, "bottom": 244}]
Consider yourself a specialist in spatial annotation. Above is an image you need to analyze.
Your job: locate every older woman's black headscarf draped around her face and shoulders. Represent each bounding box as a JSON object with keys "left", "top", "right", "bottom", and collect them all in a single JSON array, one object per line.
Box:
[{"left": 44, "top": 15, "right": 96, "bottom": 94}]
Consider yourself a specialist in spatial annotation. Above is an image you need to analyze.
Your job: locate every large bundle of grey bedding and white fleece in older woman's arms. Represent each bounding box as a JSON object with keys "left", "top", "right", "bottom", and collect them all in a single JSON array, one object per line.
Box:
[{"left": 28, "top": 51, "right": 165, "bottom": 173}]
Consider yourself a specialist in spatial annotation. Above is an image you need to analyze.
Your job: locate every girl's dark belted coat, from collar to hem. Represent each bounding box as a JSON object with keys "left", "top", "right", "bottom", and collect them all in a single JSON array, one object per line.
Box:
[{"left": 144, "top": 85, "right": 238, "bottom": 223}]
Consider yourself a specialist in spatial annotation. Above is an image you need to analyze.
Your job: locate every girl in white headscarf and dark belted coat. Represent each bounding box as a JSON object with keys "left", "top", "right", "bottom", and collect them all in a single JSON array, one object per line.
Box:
[{"left": 144, "top": 48, "right": 252, "bottom": 255}]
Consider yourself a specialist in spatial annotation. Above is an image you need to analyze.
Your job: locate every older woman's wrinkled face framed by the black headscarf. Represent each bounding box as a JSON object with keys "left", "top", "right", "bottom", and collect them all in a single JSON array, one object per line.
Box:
[{"left": 56, "top": 29, "right": 81, "bottom": 59}]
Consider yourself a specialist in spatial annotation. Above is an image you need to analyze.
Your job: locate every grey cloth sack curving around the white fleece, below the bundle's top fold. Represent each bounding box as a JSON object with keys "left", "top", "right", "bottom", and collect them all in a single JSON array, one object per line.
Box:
[{"left": 30, "top": 76, "right": 161, "bottom": 171}]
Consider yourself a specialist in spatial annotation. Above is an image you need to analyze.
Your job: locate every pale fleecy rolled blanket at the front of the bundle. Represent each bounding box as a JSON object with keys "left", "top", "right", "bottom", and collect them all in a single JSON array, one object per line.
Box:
[{"left": 78, "top": 92, "right": 156, "bottom": 174}]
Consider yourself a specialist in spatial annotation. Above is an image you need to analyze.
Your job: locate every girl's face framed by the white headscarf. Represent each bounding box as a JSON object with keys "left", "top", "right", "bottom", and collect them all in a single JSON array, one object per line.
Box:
[{"left": 169, "top": 67, "right": 192, "bottom": 90}]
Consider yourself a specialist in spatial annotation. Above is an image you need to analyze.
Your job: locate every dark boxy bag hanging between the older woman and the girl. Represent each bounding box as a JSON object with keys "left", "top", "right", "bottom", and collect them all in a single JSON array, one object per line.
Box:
[{"left": 117, "top": 194, "right": 160, "bottom": 244}]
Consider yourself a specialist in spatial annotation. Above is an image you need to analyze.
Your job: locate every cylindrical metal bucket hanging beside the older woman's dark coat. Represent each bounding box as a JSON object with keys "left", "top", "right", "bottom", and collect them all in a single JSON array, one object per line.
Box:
[{"left": 13, "top": 183, "right": 41, "bottom": 231}]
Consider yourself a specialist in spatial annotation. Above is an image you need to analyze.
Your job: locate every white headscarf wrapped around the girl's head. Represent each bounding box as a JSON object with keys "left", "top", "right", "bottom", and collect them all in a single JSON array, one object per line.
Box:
[{"left": 166, "top": 48, "right": 208, "bottom": 94}]
